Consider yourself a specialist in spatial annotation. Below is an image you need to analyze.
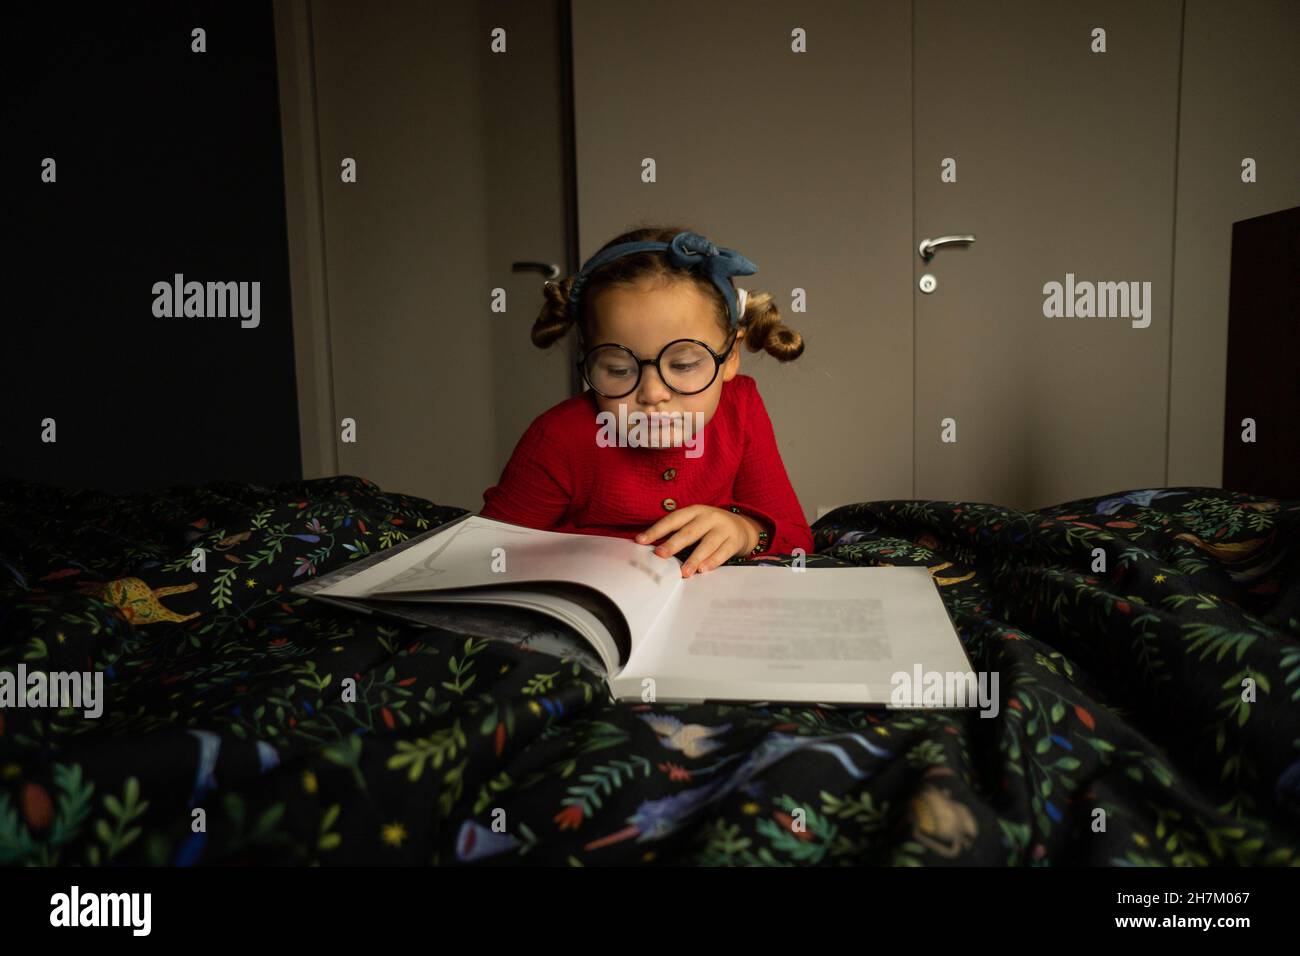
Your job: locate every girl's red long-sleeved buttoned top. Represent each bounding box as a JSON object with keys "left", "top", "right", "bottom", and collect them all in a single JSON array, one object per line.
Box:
[{"left": 481, "top": 375, "right": 813, "bottom": 558}]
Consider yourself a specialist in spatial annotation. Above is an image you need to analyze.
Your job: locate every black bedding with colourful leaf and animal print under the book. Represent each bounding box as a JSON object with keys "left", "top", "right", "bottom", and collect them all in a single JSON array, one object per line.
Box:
[{"left": 0, "top": 476, "right": 1300, "bottom": 865}]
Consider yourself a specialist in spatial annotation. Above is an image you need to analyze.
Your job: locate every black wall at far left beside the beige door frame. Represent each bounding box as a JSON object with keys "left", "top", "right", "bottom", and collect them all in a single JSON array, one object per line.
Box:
[{"left": 0, "top": 3, "right": 300, "bottom": 490}]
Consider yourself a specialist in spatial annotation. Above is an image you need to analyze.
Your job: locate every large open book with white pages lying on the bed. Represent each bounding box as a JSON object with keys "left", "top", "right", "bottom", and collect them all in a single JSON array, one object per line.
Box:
[{"left": 294, "top": 514, "right": 971, "bottom": 706}]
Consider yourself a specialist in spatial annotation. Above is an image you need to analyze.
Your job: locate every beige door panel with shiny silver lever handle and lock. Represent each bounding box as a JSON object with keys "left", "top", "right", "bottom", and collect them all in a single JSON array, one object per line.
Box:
[{"left": 913, "top": 0, "right": 1182, "bottom": 507}]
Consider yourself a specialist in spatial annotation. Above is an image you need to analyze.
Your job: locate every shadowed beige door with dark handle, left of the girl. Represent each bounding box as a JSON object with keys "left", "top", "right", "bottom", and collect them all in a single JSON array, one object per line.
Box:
[{"left": 276, "top": 0, "right": 569, "bottom": 509}]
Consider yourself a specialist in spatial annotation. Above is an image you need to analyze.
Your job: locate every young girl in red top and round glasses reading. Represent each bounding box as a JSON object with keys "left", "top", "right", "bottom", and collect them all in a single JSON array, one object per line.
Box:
[{"left": 481, "top": 228, "right": 813, "bottom": 578}]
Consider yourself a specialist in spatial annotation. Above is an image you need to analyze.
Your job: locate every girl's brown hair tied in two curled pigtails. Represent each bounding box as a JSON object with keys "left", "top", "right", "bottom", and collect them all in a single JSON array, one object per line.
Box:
[{"left": 532, "top": 226, "right": 803, "bottom": 362}]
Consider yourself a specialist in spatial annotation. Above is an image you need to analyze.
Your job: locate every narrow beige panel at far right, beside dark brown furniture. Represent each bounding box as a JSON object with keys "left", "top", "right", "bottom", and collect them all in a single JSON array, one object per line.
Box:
[{"left": 1167, "top": 0, "right": 1300, "bottom": 486}]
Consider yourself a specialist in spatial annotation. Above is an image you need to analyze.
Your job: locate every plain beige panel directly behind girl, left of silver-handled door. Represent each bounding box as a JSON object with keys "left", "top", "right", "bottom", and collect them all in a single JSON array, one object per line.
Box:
[{"left": 573, "top": 0, "right": 914, "bottom": 518}]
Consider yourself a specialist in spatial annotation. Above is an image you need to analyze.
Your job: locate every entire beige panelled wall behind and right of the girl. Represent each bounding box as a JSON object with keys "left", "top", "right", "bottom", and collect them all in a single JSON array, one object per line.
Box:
[{"left": 575, "top": 0, "right": 1300, "bottom": 518}]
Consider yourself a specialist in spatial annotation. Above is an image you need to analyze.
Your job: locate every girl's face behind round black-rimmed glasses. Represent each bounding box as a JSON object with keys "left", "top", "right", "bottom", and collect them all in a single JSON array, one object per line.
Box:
[{"left": 586, "top": 274, "right": 740, "bottom": 434}]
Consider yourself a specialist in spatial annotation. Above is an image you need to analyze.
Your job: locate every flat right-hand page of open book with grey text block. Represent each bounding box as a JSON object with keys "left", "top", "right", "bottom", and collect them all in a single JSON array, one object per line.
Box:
[{"left": 615, "top": 567, "right": 970, "bottom": 704}]
